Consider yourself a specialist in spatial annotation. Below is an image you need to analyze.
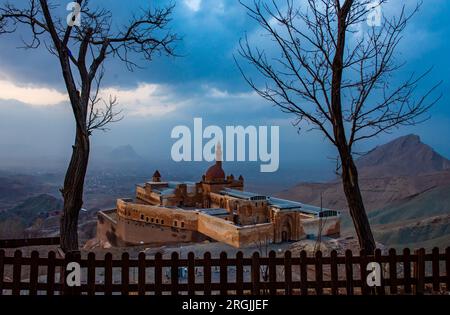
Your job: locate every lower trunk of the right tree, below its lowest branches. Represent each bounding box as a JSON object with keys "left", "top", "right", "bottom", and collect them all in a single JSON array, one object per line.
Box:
[{"left": 339, "top": 149, "right": 376, "bottom": 254}]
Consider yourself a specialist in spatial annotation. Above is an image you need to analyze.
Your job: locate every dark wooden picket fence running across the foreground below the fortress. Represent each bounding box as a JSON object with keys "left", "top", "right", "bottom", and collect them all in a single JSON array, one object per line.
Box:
[{"left": 0, "top": 247, "right": 450, "bottom": 295}]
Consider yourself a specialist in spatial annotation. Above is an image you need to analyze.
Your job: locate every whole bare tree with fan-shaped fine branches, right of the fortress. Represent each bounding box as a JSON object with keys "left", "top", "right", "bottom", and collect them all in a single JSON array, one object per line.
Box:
[{"left": 238, "top": 0, "right": 440, "bottom": 252}]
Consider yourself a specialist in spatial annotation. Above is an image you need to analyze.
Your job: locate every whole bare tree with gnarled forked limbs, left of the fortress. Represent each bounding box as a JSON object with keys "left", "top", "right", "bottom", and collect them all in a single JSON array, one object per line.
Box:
[{"left": 0, "top": 0, "right": 178, "bottom": 251}]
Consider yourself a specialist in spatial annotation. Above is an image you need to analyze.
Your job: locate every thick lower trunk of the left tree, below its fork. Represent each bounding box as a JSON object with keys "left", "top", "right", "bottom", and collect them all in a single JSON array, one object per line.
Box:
[{"left": 60, "top": 127, "right": 89, "bottom": 252}]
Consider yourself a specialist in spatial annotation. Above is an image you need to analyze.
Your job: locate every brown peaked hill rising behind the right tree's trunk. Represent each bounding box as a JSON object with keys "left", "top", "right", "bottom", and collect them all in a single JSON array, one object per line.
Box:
[{"left": 277, "top": 135, "right": 450, "bottom": 211}]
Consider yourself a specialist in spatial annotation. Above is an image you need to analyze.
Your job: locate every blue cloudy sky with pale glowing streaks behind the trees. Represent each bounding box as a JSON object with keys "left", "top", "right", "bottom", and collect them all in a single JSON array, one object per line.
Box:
[{"left": 0, "top": 0, "right": 450, "bottom": 180}]
